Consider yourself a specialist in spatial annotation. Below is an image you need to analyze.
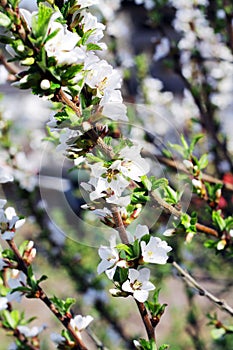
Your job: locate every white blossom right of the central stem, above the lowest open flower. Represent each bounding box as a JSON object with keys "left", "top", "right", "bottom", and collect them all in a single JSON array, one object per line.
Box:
[{"left": 141, "top": 237, "right": 172, "bottom": 264}]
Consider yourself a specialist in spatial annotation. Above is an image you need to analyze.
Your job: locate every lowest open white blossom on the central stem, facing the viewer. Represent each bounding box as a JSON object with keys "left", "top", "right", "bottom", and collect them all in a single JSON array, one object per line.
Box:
[{"left": 122, "top": 268, "right": 155, "bottom": 303}]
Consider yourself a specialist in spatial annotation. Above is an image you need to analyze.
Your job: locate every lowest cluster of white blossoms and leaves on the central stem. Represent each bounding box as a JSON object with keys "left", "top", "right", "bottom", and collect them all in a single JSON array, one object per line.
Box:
[{"left": 97, "top": 225, "right": 172, "bottom": 302}]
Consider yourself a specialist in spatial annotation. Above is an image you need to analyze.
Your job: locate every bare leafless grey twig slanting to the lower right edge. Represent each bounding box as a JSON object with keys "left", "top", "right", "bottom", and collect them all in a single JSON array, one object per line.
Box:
[{"left": 172, "top": 261, "right": 233, "bottom": 317}]
